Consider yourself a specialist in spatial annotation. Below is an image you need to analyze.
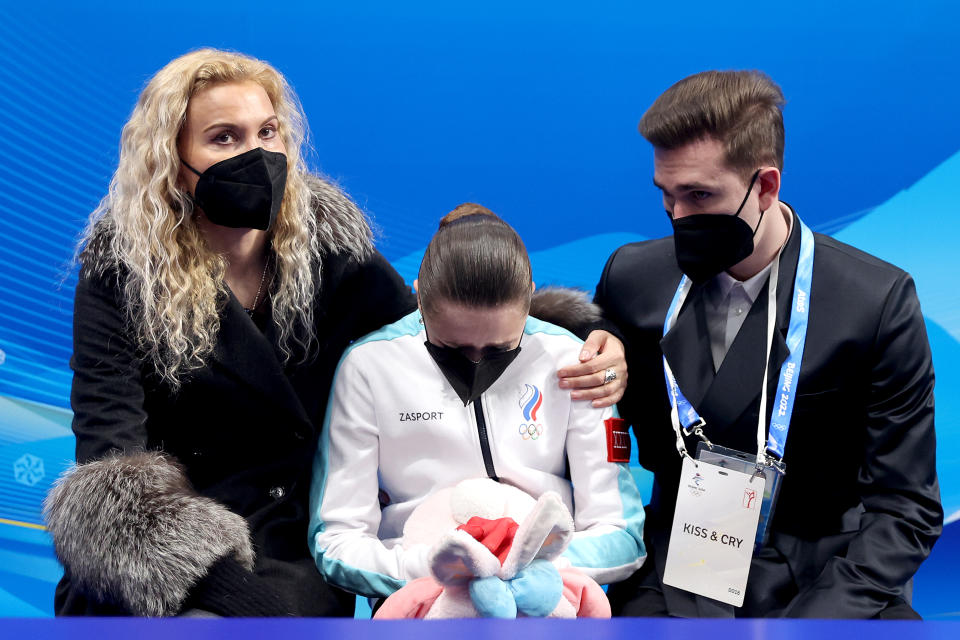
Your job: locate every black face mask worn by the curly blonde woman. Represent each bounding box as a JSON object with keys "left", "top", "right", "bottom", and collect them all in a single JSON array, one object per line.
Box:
[{"left": 180, "top": 147, "right": 287, "bottom": 231}]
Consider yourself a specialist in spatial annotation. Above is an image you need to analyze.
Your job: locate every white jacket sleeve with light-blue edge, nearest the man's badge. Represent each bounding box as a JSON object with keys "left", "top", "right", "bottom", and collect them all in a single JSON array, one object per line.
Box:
[{"left": 563, "top": 400, "right": 647, "bottom": 584}]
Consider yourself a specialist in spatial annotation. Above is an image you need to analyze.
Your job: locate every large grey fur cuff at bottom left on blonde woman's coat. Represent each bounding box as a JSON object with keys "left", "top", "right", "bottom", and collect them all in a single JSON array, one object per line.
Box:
[{"left": 44, "top": 452, "right": 253, "bottom": 616}]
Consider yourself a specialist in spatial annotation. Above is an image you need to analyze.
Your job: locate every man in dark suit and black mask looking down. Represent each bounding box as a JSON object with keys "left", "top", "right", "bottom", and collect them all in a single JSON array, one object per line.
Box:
[{"left": 596, "top": 72, "right": 943, "bottom": 618}]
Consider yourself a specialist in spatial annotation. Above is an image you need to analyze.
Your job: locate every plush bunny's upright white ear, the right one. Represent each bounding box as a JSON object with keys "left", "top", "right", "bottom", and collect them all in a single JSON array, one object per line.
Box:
[{"left": 498, "top": 491, "right": 573, "bottom": 580}]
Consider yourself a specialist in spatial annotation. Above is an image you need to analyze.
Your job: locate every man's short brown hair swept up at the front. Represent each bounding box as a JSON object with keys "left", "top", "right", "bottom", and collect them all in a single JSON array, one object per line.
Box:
[{"left": 639, "top": 71, "right": 785, "bottom": 180}]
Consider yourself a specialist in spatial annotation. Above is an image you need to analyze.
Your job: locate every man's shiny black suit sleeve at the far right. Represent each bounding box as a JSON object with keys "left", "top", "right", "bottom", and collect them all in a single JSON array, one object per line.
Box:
[{"left": 785, "top": 274, "right": 943, "bottom": 618}]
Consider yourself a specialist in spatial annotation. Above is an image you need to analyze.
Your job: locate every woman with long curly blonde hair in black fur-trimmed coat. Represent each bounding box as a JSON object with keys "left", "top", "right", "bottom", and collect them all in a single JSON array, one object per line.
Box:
[{"left": 47, "top": 49, "right": 415, "bottom": 616}]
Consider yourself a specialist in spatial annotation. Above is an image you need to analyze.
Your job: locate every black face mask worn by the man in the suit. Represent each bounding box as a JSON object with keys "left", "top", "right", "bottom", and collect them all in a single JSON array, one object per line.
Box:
[{"left": 671, "top": 169, "right": 764, "bottom": 283}]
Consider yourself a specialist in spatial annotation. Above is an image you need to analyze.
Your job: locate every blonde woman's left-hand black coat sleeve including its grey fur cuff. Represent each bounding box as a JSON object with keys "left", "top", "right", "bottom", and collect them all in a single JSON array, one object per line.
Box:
[{"left": 59, "top": 274, "right": 262, "bottom": 615}]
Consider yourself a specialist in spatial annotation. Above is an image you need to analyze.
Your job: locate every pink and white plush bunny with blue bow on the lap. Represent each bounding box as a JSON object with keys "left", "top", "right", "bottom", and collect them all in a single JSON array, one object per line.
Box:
[{"left": 374, "top": 479, "right": 610, "bottom": 619}]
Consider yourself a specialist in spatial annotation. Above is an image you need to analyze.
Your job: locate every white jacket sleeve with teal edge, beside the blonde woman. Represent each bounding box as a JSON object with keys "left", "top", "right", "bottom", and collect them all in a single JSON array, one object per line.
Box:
[{"left": 308, "top": 351, "right": 429, "bottom": 597}]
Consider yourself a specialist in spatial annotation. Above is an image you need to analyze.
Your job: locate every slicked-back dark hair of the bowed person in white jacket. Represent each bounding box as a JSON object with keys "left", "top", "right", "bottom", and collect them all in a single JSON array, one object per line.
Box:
[{"left": 417, "top": 202, "right": 532, "bottom": 313}]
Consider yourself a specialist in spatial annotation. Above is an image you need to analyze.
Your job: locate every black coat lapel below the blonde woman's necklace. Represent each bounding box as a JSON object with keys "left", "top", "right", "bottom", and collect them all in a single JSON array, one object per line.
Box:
[{"left": 213, "top": 294, "right": 309, "bottom": 422}]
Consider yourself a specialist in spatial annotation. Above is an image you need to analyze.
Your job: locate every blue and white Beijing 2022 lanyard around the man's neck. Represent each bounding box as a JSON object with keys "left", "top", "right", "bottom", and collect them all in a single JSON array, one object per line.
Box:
[{"left": 663, "top": 217, "right": 813, "bottom": 461}]
